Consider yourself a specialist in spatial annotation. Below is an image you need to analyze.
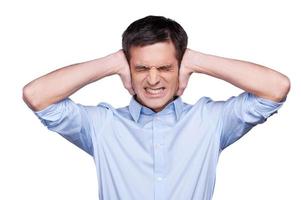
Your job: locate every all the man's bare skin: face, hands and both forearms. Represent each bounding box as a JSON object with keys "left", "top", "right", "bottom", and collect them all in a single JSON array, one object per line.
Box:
[{"left": 23, "top": 42, "right": 290, "bottom": 112}]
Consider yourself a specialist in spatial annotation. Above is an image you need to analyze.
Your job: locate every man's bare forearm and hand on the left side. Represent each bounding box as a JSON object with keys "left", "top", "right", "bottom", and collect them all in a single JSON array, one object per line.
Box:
[{"left": 23, "top": 50, "right": 133, "bottom": 111}]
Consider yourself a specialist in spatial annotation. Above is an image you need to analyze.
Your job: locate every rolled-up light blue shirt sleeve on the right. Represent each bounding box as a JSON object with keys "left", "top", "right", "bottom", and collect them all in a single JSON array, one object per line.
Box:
[{"left": 220, "top": 92, "right": 285, "bottom": 149}]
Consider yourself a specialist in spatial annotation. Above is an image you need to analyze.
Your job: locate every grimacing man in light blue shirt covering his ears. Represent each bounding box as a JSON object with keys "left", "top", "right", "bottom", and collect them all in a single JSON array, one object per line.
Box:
[{"left": 23, "top": 16, "right": 290, "bottom": 200}]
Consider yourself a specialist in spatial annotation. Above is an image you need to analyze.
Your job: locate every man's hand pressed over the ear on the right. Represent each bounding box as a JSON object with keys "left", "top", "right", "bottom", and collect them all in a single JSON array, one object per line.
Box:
[{"left": 177, "top": 48, "right": 197, "bottom": 96}]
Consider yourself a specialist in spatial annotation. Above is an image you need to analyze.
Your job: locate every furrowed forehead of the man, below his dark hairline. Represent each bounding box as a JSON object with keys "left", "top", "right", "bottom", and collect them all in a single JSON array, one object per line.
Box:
[{"left": 130, "top": 42, "right": 177, "bottom": 65}]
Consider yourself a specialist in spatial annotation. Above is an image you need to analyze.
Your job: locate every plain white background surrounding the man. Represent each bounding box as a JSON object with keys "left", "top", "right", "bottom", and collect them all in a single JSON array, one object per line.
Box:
[{"left": 0, "top": 0, "right": 301, "bottom": 200}]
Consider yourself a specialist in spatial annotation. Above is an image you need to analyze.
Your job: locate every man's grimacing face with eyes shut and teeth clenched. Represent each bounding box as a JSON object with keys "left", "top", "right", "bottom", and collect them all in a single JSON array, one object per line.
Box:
[{"left": 130, "top": 42, "right": 179, "bottom": 112}]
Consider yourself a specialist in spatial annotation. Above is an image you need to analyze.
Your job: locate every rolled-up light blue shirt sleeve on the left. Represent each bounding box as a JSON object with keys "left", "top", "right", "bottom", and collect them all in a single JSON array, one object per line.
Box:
[{"left": 35, "top": 98, "right": 93, "bottom": 155}]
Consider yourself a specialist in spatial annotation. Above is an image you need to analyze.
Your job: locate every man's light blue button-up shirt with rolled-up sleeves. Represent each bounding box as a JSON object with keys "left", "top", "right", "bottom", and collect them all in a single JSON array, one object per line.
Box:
[{"left": 35, "top": 92, "right": 283, "bottom": 200}]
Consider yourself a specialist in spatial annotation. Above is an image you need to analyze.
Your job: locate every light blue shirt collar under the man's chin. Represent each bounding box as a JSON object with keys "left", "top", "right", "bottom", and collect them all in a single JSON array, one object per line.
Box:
[{"left": 129, "top": 96, "right": 183, "bottom": 122}]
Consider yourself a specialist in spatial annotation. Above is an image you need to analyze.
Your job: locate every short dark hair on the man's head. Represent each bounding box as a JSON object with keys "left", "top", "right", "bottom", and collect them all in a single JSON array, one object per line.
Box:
[{"left": 122, "top": 15, "right": 188, "bottom": 65}]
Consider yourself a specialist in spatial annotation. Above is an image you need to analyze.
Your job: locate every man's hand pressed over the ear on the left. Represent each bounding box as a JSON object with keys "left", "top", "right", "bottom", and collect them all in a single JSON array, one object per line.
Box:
[{"left": 114, "top": 49, "right": 135, "bottom": 95}]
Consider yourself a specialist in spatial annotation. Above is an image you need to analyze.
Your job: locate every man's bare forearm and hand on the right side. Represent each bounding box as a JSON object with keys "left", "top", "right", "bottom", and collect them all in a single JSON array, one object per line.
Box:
[{"left": 178, "top": 49, "right": 290, "bottom": 102}]
